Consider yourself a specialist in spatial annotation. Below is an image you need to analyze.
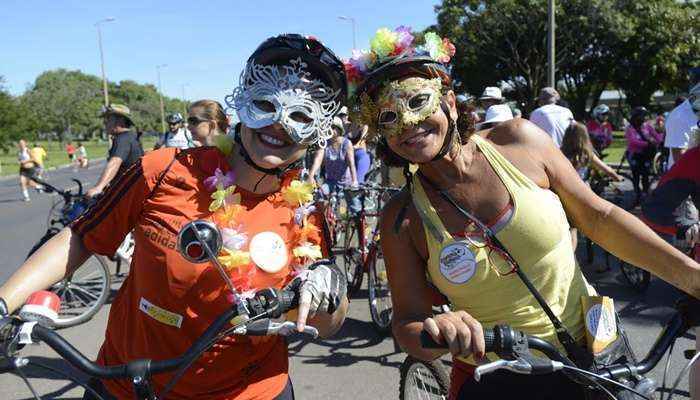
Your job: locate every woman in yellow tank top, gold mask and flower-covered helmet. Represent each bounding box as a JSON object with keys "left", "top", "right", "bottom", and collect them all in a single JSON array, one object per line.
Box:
[{"left": 346, "top": 27, "right": 700, "bottom": 399}]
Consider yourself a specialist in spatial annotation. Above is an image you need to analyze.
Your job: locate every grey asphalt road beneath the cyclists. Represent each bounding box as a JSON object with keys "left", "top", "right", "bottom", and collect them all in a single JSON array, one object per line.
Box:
[{"left": 0, "top": 164, "right": 693, "bottom": 400}]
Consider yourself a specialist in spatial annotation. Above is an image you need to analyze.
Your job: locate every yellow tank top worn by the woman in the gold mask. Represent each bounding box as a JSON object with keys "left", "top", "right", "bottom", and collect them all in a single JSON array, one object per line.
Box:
[{"left": 412, "top": 135, "right": 594, "bottom": 363}]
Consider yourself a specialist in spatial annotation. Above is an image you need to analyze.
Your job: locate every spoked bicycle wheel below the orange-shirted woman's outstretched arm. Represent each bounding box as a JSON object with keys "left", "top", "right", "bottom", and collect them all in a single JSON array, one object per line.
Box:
[{"left": 50, "top": 255, "right": 112, "bottom": 328}]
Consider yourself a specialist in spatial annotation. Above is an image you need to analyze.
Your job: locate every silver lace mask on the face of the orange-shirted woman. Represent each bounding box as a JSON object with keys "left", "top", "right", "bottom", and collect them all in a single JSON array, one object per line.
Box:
[{"left": 225, "top": 58, "right": 341, "bottom": 147}]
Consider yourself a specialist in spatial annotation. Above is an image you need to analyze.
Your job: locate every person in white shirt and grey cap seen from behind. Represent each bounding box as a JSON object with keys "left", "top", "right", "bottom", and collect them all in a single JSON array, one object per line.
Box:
[{"left": 530, "top": 87, "right": 574, "bottom": 147}]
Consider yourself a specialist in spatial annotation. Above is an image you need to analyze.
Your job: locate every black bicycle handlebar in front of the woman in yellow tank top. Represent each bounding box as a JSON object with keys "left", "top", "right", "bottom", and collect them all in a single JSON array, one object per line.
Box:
[{"left": 415, "top": 297, "right": 700, "bottom": 400}]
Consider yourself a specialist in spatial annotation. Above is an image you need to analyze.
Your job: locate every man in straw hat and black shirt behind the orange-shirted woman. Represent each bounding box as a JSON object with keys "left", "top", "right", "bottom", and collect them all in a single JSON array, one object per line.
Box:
[{"left": 85, "top": 104, "right": 143, "bottom": 197}]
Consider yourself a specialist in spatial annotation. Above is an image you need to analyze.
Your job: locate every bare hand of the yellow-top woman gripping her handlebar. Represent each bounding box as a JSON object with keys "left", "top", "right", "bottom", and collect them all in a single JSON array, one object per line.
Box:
[{"left": 423, "top": 311, "right": 486, "bottom": 359}]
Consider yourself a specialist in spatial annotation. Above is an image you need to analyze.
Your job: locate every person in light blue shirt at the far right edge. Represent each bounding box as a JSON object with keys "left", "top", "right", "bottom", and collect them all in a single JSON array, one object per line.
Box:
[{"left": 664, "top": 83, "right": 700, "bottom": 168}]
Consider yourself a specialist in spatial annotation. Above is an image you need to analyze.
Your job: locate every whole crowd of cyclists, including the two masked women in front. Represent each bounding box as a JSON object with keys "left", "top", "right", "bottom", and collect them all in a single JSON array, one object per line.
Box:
[{"left": 0, "top": 27, "right": 700, "bottom": 399}]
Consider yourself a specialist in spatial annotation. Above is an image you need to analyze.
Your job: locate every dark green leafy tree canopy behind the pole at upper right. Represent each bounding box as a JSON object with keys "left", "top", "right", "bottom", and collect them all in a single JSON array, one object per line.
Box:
[{"left": 428, "top": 0, "right": 700, "bottom": 118}]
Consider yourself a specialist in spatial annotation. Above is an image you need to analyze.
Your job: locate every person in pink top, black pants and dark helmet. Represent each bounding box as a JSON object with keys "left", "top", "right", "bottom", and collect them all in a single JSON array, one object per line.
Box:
[{"left": 625, "top": 107, "right": 663, "bottom": 204}]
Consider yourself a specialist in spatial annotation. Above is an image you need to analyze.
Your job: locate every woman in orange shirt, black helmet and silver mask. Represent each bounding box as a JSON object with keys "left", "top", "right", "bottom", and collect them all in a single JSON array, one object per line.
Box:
[{"left": 0, "top": 34, "right": 347, "bottom": 400}]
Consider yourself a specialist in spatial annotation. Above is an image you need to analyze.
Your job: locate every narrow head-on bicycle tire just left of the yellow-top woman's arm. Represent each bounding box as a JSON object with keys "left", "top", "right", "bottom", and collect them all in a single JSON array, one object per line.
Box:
[{"left": 367, "top": 242, "right": 393, "bottom": 334}]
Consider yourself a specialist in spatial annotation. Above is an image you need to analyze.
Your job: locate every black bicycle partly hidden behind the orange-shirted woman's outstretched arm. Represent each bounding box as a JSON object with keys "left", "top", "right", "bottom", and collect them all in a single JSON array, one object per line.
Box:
[{"left": 27, "top": 179, "right": 112, "bottom": 328}]
